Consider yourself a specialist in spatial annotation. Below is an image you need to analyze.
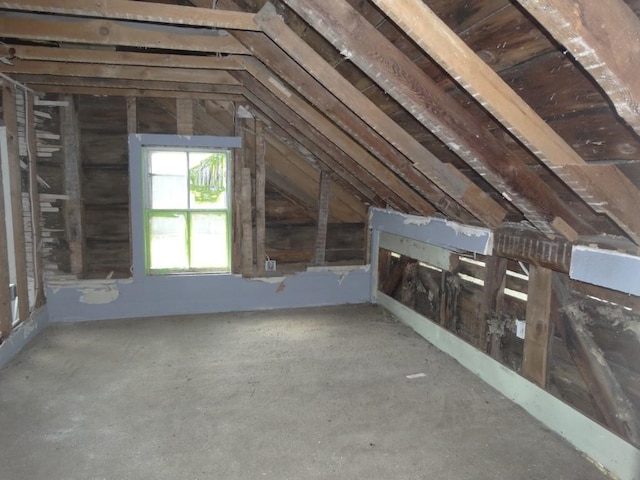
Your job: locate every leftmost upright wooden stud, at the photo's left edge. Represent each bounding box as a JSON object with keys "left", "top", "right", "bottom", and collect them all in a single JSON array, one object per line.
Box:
[{"left": 2, "top": 82, "right": 29, "bottom": 322}]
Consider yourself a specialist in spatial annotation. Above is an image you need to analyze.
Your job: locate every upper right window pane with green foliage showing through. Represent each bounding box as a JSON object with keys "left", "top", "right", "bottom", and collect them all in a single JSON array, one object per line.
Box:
[{"left": 189, "top": 152, "right": 227, "bottom": 210}]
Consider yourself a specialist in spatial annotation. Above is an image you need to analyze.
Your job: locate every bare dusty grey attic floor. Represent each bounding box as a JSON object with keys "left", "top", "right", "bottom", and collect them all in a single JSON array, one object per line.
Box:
[{"left": 0, "top": 306, "right": 605, "bottom": 480}]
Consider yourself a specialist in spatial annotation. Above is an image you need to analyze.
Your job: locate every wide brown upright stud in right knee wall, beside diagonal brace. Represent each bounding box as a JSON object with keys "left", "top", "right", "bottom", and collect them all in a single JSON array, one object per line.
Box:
[{"left": 522, "top": 265, "right": 553, "bottom": 388}]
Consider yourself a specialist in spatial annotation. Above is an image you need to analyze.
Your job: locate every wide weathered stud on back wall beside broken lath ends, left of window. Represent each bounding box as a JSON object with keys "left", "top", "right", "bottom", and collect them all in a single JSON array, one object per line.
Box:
[{"left": 60, "top": 95, "right": 85, "bottom": 278}]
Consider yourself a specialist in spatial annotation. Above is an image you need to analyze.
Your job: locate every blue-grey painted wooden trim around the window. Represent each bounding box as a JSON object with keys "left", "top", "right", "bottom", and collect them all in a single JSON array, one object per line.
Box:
[{"left": 129, "top": 134, "right": 242, "bottom": 279}]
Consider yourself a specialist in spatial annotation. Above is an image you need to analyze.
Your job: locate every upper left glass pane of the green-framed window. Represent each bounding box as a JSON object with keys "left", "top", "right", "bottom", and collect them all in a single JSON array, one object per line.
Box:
[{"left": 149, "top": 151, "right": 189, "bottom": 210}]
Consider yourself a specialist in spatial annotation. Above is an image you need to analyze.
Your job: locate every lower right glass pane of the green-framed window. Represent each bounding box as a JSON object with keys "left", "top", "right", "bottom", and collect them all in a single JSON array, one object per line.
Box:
[{"left": 191, "top": 213, "right": 229, "bottom": 271}]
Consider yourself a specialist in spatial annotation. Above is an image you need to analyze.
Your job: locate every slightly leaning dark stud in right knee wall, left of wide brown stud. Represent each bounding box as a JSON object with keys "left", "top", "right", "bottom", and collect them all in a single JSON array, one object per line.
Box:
[{"left": 476, "top": 255, "right": 508, "bottom": 359}]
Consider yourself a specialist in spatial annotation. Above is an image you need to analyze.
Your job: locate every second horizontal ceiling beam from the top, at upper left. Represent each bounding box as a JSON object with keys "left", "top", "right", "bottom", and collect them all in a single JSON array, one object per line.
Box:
[{"left": 0, "top": 13, "right": 249, "bottom": 55}]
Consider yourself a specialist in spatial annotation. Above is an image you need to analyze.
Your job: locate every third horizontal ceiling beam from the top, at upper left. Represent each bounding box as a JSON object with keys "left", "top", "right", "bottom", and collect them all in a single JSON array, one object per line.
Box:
[{"left": 0, "top": 44, "right": 242, "bottom": 70}]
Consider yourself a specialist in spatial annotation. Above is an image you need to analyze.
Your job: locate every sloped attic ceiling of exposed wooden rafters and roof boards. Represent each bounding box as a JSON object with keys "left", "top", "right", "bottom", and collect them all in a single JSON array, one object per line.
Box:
[{"left": 0, "top": 0, "right": 640, "bottom": 248}]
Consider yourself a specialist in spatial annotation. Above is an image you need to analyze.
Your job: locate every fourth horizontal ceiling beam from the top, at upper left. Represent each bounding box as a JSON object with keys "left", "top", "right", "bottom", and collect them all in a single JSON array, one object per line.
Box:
[{"left": 0, "top": 60, "right": 238, "bottom": 85}]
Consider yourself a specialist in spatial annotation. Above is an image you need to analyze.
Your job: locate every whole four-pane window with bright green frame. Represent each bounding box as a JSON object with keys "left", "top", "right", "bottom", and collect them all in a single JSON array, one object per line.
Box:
[{"left": 143, "top": 148, "right": 231, "bottom": 273}]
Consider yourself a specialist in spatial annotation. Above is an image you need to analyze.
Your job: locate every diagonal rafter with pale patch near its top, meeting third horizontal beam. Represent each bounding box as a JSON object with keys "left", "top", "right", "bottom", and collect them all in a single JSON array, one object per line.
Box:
[{"left": 232, "top": 61, "right": 435, "bottom": 215}]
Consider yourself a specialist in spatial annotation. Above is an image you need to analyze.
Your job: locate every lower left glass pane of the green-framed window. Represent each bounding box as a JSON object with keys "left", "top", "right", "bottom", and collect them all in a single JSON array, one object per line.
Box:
[{"left": 149, "top": 213, "right": 189, "bottom": 270}]
